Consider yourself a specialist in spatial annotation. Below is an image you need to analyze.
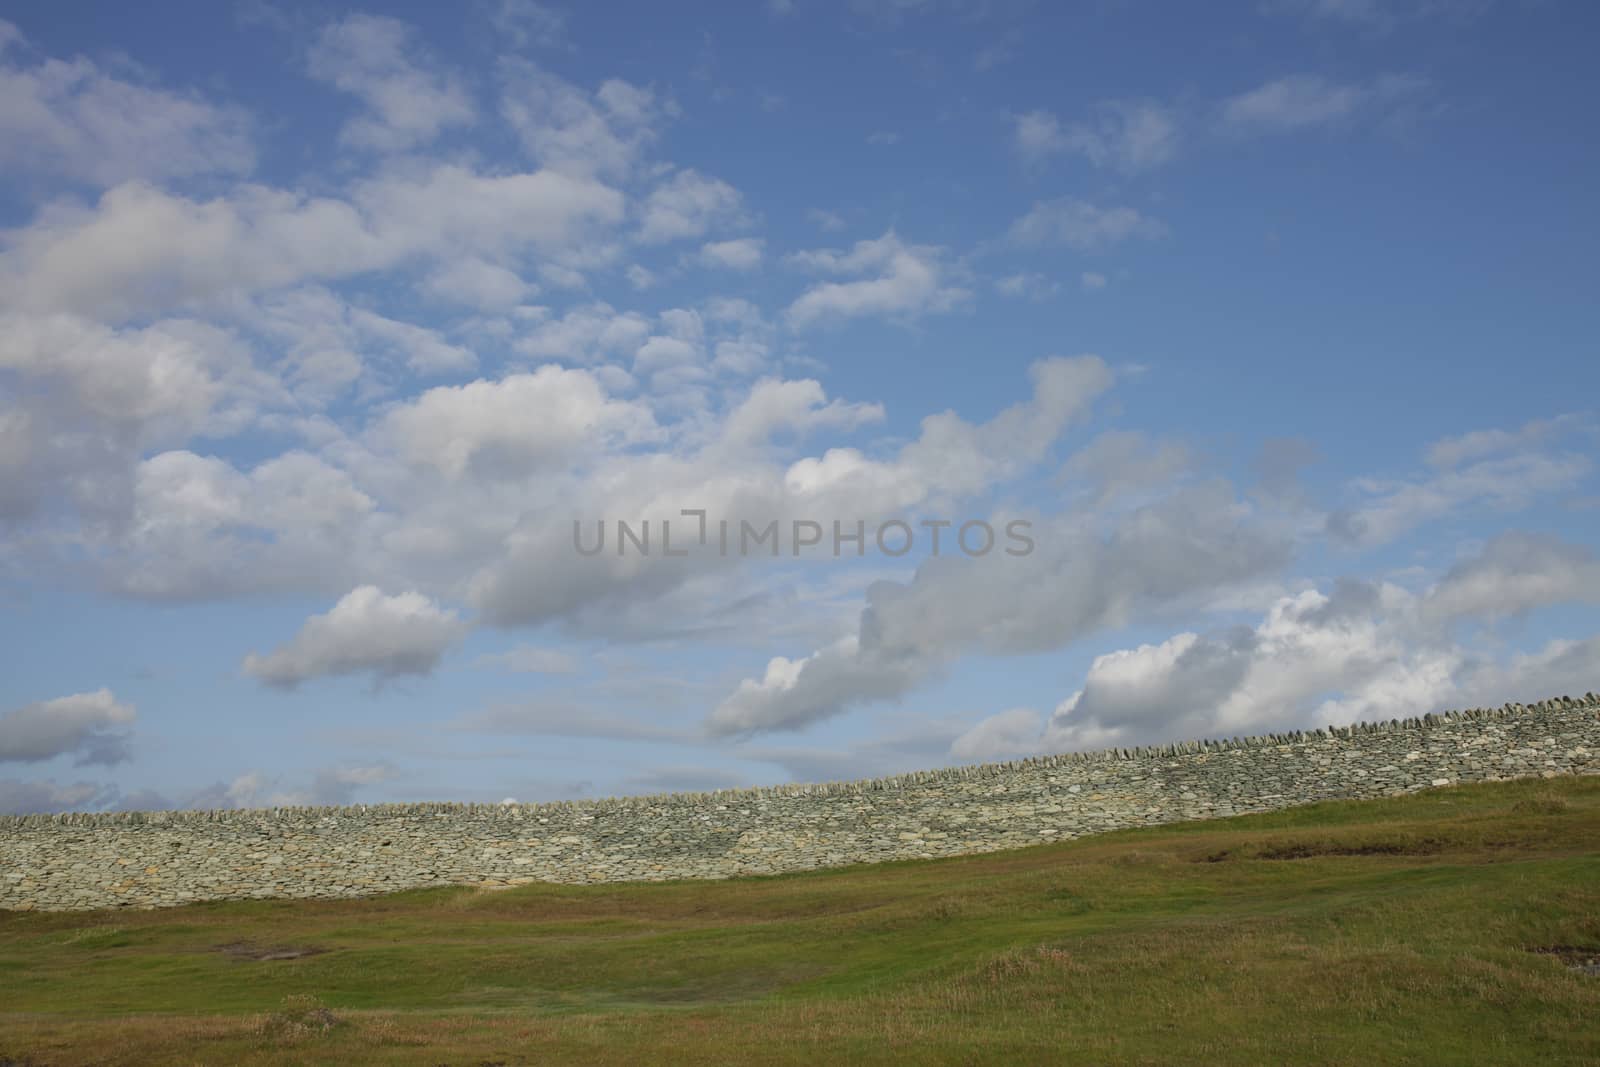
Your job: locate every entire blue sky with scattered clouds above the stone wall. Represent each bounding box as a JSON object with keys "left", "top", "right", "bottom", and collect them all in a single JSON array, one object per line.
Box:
[{"left": 0, "top": 0, "right": 1600, "bottom": 813}]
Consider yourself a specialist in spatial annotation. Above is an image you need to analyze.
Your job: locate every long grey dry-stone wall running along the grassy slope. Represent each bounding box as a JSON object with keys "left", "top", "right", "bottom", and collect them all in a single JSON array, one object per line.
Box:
[{"left": 0, "top": 693, "right": 1600, "bottom": 910}]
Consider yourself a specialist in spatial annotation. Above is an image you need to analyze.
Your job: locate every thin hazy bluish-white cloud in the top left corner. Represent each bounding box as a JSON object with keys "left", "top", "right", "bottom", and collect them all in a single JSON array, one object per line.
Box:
[{"left": 0, "top": 22, "right": 254, "bottom": 186}]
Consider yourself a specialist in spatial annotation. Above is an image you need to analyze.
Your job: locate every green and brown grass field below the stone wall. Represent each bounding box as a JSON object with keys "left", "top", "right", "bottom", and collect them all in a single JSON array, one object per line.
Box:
[{"left": 0, "top": 777, "right": 1600, "bottom": 1064}]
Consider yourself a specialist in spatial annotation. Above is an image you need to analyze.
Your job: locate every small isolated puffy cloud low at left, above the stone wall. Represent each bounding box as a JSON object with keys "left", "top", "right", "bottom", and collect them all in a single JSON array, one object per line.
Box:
[{"left": 245, "top": 585, "right": 466, "bottom": 688}]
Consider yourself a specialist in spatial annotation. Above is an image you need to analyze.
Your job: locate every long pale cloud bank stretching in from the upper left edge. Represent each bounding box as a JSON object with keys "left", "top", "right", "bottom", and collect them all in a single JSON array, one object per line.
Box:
[{"left": 0, "top": 165, "right": 622, "bottom": 320}]
